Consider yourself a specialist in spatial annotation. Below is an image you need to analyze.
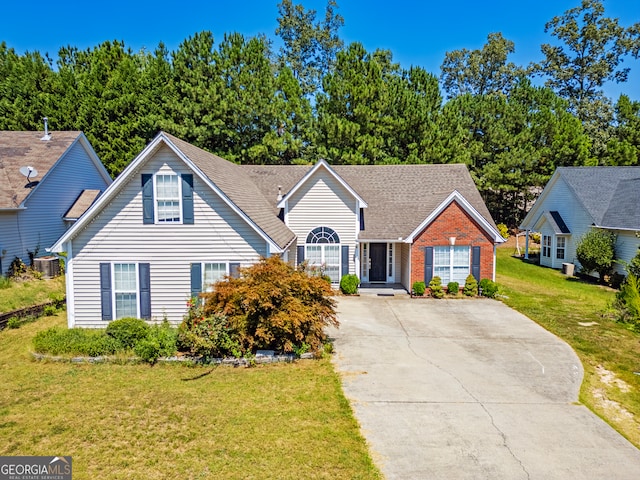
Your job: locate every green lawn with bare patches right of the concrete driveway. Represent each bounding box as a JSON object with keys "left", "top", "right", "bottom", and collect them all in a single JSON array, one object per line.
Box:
[{"left": 496, "top": 247, "right": 640, "bottom": 448}]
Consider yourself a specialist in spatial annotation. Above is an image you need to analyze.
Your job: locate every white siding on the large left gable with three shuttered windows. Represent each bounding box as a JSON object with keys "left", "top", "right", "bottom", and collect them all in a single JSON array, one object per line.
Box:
[{"left": 72, "top": 147, "right": 268, "bottom": 328}]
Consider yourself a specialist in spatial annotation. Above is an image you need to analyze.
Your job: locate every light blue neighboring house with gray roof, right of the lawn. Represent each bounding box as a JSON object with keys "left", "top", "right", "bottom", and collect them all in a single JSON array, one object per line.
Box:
[{"left": 520, "top": 167, "right": 640, "bottom": 274}]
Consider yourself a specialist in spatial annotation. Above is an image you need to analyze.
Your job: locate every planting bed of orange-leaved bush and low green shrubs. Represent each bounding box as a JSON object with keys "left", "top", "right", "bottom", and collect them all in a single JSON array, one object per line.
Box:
[{"left": 34, "top": 256, "right": 340, "bottom": 364}]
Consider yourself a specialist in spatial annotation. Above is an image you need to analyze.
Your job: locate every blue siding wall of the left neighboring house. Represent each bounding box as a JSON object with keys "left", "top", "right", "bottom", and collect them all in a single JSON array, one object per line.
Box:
[{"left": 0, "top": 137, "right": 111, "bottom": 273}]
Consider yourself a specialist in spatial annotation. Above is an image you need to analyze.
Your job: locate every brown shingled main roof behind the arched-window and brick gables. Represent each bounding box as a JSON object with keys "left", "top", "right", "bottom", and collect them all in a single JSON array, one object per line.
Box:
[{"left": 241, "top": 164, "right": 495, "bottom": 240}]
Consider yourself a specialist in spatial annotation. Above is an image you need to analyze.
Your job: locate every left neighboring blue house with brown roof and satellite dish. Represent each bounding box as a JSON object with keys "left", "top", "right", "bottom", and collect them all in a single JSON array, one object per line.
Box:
[{"left": 0, "top": 131, "right": 111, "bottom": 274}]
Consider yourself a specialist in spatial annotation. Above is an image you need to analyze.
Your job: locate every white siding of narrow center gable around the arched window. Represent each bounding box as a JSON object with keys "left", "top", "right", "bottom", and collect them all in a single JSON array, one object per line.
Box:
[{"left": 285, "top": 169, "right": 359, "bottom": 281}]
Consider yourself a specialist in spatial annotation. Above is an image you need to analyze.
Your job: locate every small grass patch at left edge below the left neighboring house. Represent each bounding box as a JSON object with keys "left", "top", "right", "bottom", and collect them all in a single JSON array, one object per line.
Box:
[{"left": 0, "top": 276, "right": 65, "bottom": 313}]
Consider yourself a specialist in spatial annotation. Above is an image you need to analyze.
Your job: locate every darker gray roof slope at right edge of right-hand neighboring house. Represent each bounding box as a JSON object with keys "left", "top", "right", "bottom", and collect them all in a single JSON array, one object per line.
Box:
[{"left": 600, "top": 177, "right": 640, "bottom": 230}]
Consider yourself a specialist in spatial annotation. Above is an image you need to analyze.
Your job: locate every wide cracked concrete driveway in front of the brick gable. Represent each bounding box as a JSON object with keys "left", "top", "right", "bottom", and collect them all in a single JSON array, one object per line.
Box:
[{"left": 330, "top": 296, "right": 640, "bottom": 480}]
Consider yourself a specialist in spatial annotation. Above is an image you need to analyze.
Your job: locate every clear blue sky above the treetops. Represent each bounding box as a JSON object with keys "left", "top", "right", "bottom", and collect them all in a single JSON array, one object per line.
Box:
[{"left": 0, "top": 0, "right": 640, "bottom": 100}]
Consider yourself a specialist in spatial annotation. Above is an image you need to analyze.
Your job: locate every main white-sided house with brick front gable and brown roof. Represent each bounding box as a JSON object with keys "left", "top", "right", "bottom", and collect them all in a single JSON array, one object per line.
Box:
[{"left": 51, "top": 132, "right": 503, "bottom": 327}]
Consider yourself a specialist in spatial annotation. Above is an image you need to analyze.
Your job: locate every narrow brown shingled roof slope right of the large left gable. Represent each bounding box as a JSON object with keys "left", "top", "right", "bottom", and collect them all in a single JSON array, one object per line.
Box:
[{"left": 163, "top": 133, "right": 298, "bottom": 248}]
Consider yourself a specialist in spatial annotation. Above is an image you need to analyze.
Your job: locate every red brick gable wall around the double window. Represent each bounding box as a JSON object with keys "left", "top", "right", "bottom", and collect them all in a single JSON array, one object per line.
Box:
[{"left": 411, "top": 201, "right": 493, "bottom": 285}]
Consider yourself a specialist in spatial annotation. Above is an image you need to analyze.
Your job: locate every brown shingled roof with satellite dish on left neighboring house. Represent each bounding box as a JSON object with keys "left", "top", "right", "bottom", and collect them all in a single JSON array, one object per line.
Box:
[{"left": 0, "top": 131, "right": 81, "bottom": 208}]
